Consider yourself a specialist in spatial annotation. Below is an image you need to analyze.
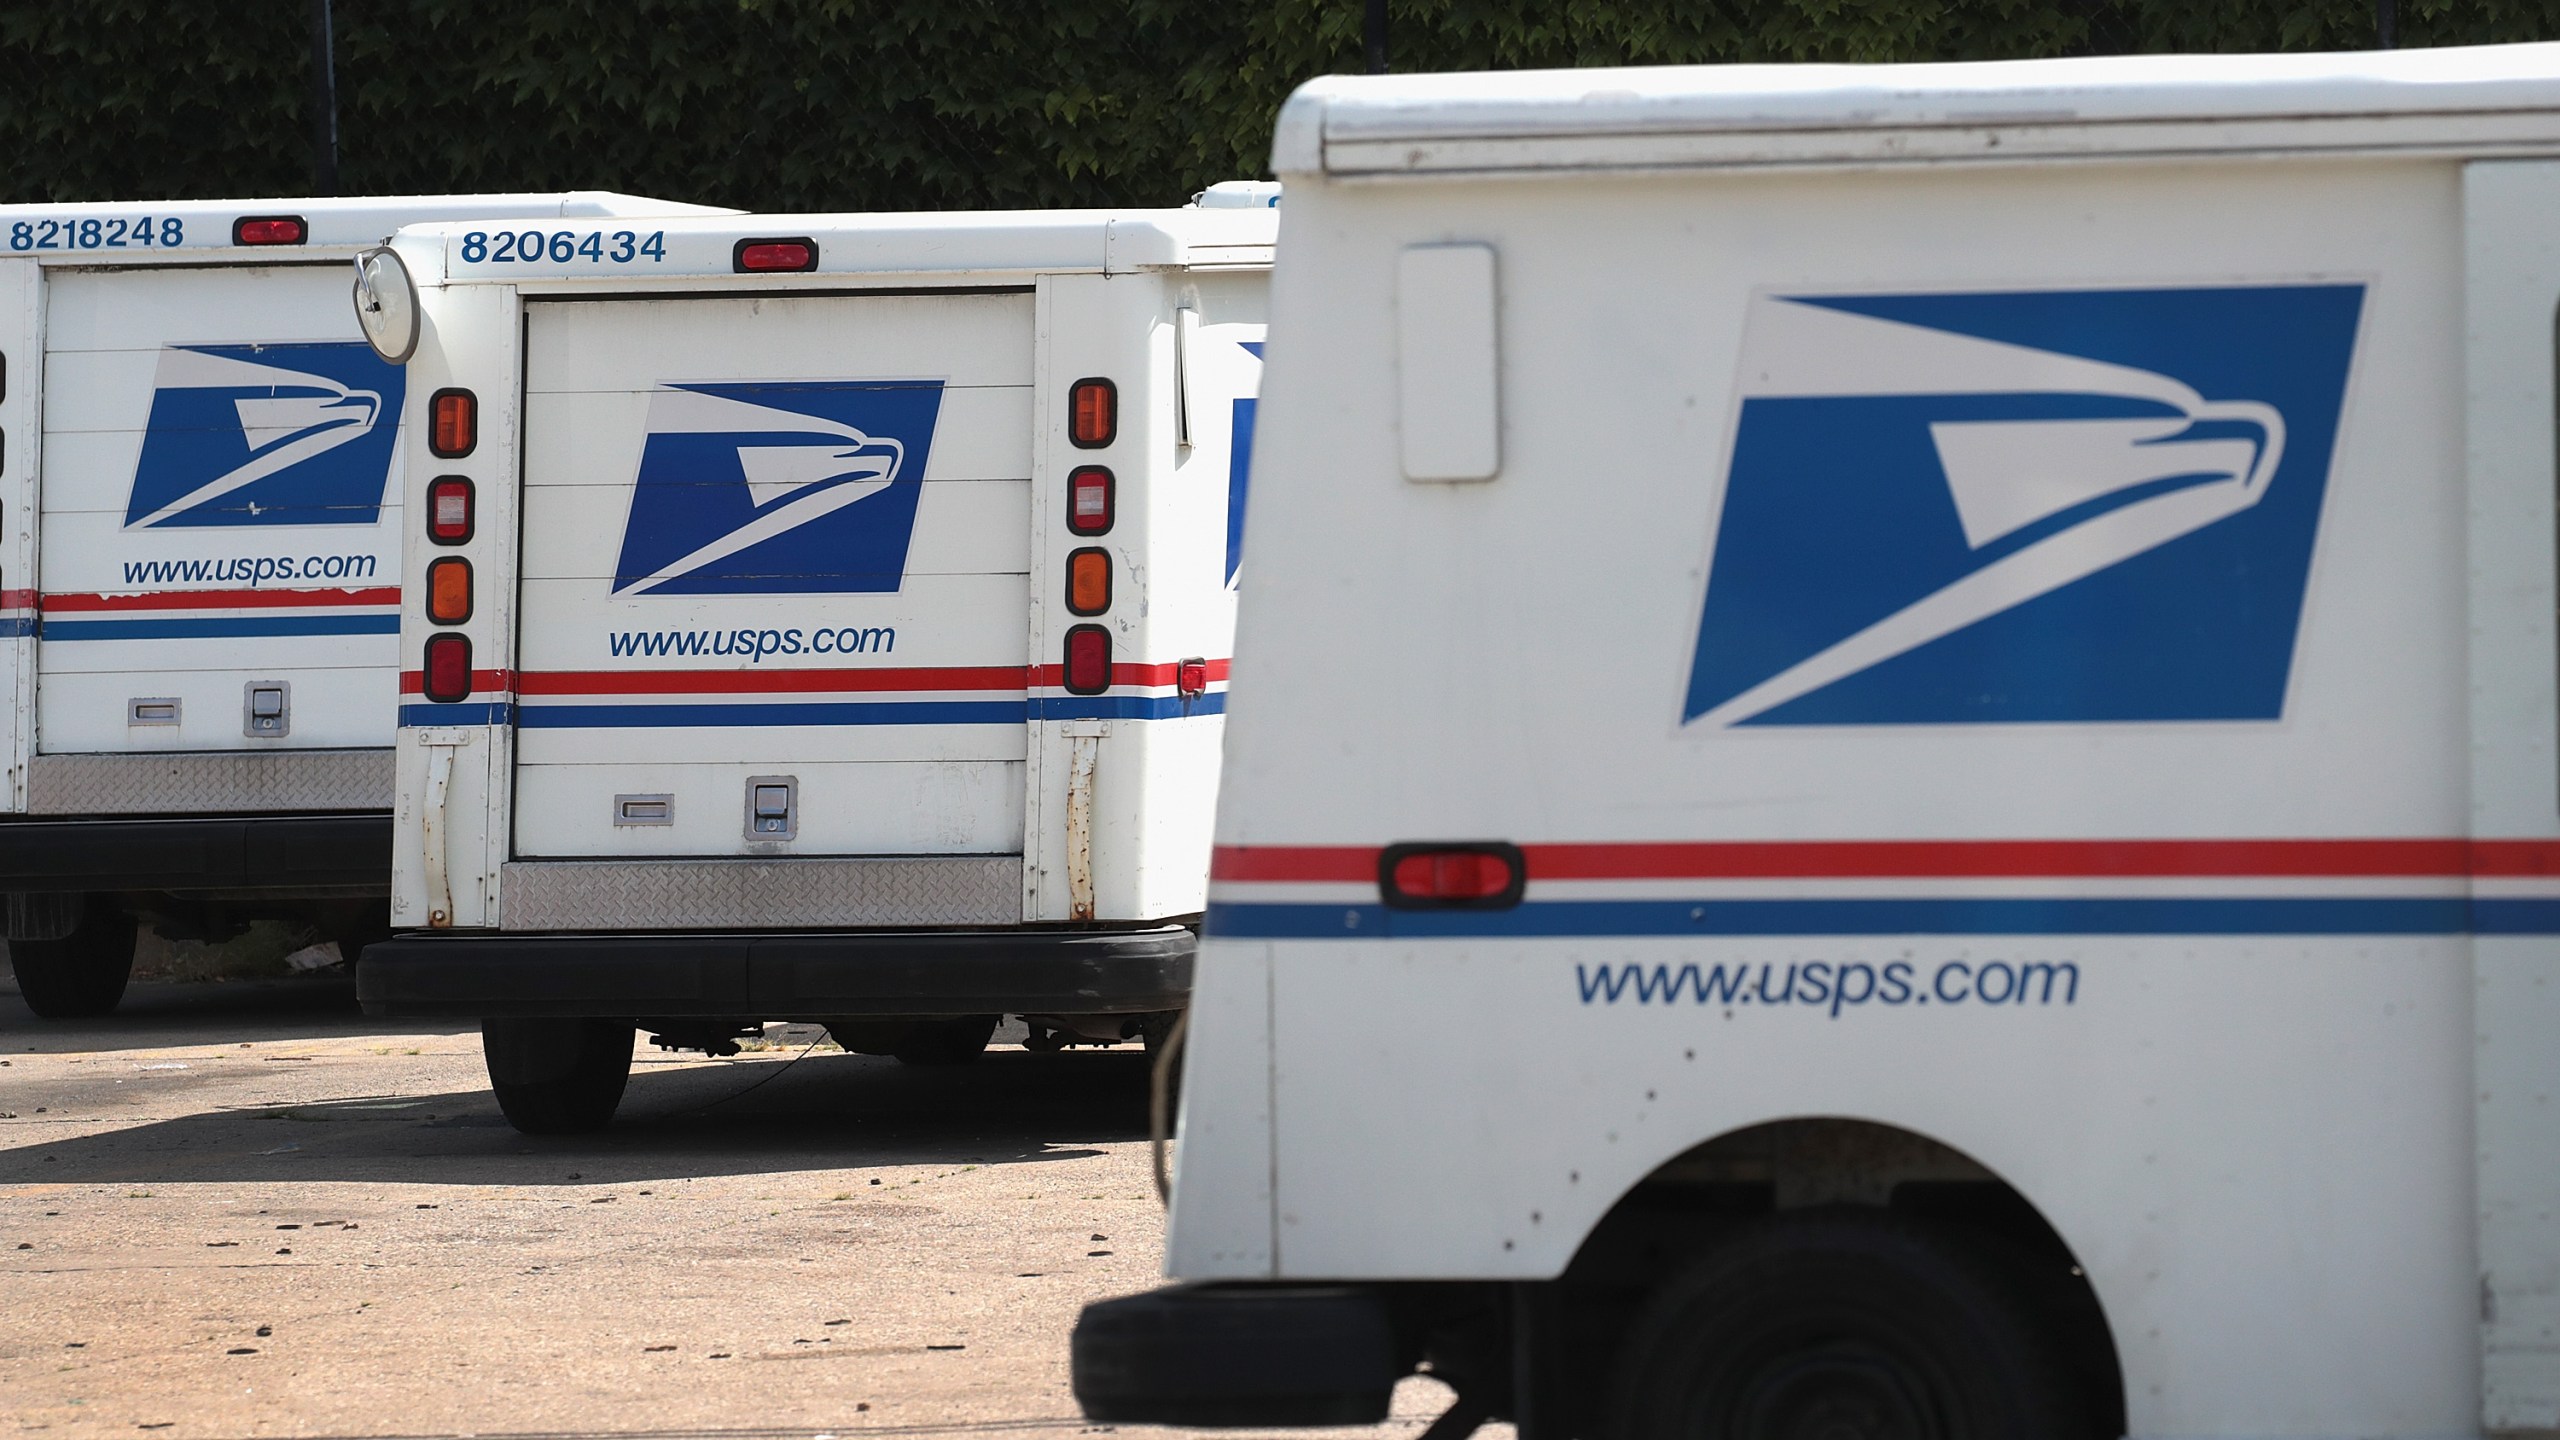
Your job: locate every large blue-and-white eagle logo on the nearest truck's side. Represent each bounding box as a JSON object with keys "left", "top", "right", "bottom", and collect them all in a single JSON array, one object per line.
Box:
[{"left": 1684, "top": 284, "right": 2365, "bottom": 725}]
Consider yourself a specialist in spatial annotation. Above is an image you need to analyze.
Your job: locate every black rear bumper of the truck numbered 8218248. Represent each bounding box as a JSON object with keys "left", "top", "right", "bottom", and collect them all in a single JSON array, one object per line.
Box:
[{"left": 0, "top": 812, "right": 392, "bottom": 899}]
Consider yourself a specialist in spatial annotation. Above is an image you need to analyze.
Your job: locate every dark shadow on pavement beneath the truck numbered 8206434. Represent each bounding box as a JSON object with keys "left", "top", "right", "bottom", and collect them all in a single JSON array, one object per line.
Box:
[{"left": 0, "top": 1048, "right": 1149, "bottom": 1186}]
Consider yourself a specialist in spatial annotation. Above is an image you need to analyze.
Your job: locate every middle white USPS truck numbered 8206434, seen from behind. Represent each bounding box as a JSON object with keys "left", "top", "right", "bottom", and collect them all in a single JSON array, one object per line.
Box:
[{"left": 358, "top": 187, "right": 1277, "bottom": 1130}]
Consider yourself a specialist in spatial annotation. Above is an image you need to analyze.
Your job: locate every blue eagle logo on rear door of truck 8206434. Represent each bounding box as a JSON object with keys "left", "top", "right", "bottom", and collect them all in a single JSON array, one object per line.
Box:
[{"left": 614, "top": 379, "right": 942, "bottom": 594}]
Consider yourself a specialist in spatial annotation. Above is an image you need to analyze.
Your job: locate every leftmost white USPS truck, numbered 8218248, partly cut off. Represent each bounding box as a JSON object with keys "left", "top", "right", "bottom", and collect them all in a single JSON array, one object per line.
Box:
[{"left": 0, "top": 192, "right": 704, "bottom": 1017}]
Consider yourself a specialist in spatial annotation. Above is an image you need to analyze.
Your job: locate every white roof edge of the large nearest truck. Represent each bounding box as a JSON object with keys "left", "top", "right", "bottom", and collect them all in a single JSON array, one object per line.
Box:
[{"left": 1272, "top": 44, "right": 2560, "bottom": 179}]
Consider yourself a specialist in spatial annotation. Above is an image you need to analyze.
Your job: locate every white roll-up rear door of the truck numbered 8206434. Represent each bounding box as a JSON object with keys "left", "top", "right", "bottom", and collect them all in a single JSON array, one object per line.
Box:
[{"left": 512, "top": 290, "right": 1034, "bottom": 858}]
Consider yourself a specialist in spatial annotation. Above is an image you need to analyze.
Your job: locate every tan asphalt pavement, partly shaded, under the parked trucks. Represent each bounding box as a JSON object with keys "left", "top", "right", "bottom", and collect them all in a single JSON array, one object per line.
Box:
[{"left": 0, "top": 974, "right": 1474, "bottom": 1440}]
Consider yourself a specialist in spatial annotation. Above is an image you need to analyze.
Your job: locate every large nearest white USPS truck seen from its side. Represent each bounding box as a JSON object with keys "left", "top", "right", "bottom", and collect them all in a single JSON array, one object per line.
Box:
[{"left": 1075, "top": 46, "right": 2560, "bottom": 1440}]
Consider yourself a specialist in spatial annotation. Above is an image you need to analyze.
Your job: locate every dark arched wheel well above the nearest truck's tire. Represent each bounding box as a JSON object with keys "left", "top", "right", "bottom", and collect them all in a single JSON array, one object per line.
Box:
[{"left": 1559, "top": 1117, "right": 2125, "bottom": 1435}]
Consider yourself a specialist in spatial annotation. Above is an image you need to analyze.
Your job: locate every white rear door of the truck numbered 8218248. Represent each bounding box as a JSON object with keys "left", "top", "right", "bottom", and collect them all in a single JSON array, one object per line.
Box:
[{"left": 32, "top": 264, "right": 404, "bottom": 763}]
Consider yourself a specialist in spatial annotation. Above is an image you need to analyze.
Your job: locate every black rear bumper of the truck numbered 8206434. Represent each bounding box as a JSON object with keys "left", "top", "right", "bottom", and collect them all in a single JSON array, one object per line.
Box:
[{"left": 356, "top": 928, "right": 1198, "bottom": 1020}]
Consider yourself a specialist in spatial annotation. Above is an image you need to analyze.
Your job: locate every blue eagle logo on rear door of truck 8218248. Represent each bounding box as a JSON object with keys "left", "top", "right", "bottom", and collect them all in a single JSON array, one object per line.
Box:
[{"left": 125, "top": 341, "right": 402, "bottom": 528}]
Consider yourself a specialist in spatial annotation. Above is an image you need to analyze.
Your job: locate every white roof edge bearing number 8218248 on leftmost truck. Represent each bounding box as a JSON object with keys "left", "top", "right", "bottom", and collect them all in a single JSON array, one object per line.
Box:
[{"left": 0, "top": 190, "right": 735, "bottom": 266}]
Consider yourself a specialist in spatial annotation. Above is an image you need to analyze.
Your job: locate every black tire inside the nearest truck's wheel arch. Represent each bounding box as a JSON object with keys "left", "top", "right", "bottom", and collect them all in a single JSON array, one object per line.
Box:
[{"left": 1605, "top": 1209, "right": 2089, "bottom": 1440}]
